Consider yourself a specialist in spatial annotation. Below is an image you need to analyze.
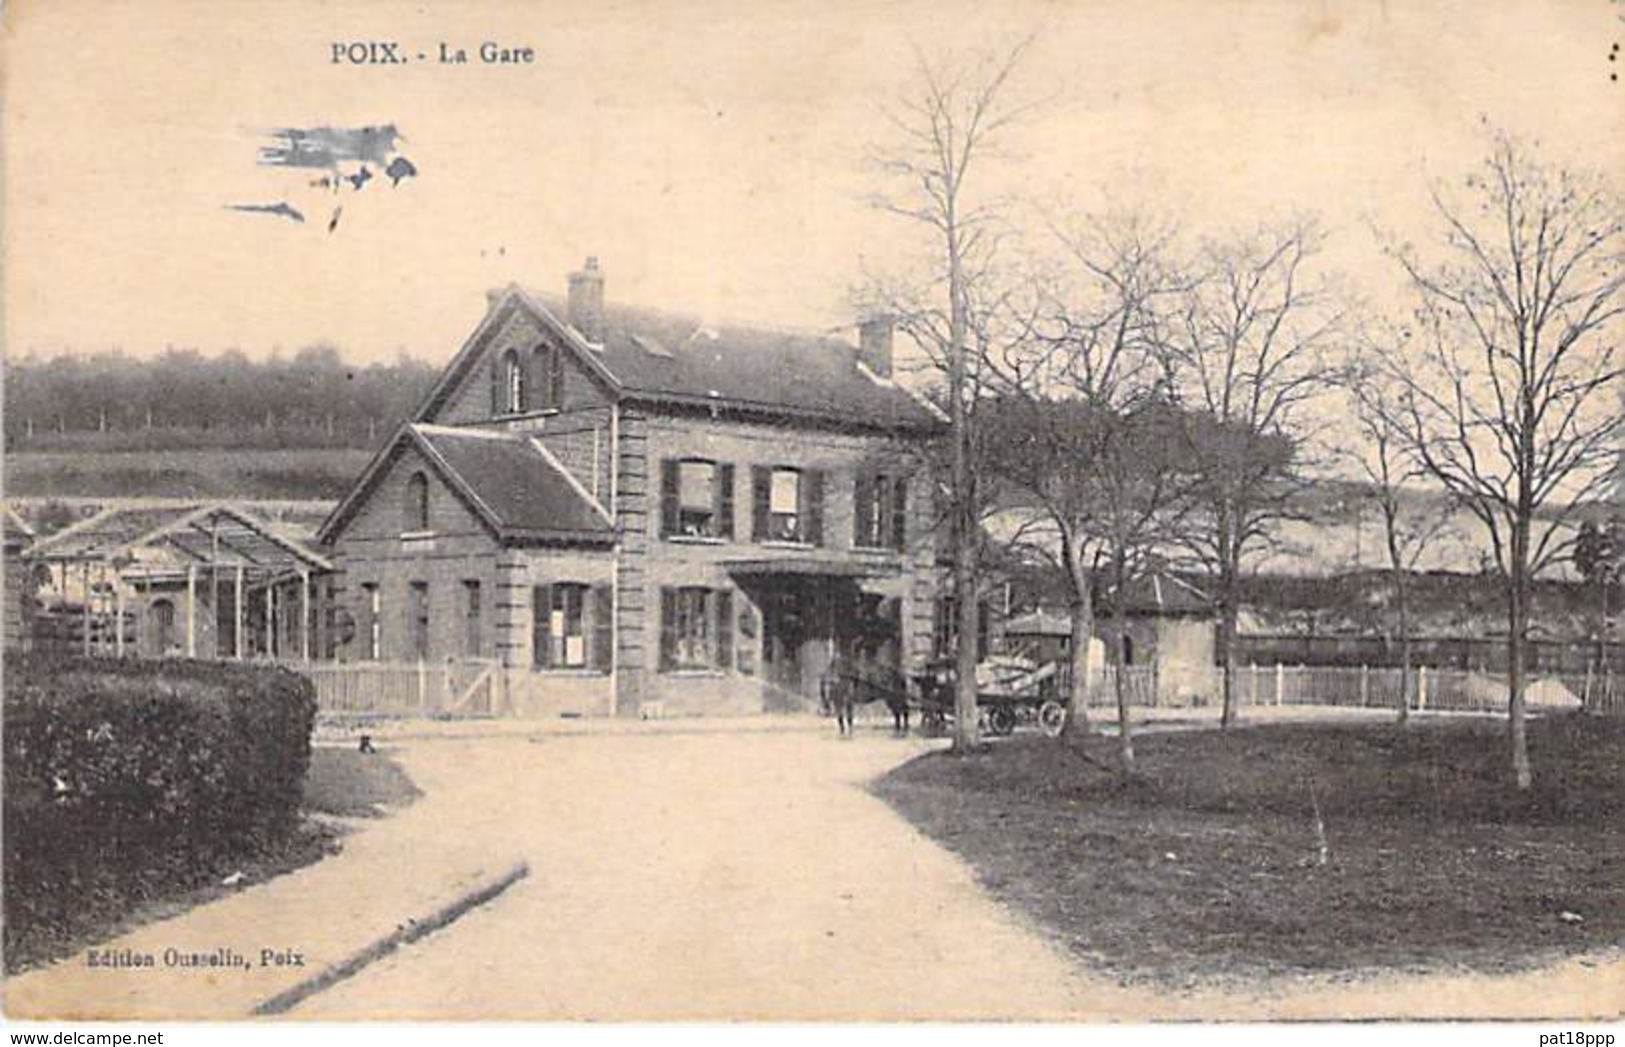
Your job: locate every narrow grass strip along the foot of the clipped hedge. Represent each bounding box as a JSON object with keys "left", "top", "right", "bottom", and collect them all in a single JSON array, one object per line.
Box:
[{"left": 5, "top": 748, "right": 419, "bottom": 974}]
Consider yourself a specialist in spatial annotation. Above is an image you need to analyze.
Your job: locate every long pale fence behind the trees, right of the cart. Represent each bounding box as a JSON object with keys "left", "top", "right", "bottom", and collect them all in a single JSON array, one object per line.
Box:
[{"left": 1089, "top": 665, "right": 1625, "bottom": 715}]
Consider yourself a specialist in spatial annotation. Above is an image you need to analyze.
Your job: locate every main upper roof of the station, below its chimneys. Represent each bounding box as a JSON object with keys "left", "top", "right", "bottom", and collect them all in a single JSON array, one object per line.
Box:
[{"left": 416, "top": 286, "right": 946, "bottom": 434}]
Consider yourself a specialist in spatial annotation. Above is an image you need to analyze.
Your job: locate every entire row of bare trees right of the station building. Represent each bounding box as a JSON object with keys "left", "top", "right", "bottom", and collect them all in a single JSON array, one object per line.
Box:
[{"left": 884, "top": 44, "right": 1625, "bottom": 789}]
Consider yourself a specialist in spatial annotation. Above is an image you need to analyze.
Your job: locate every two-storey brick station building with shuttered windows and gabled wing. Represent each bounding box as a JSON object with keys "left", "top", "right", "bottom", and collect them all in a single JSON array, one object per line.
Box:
[{"left": 319, "top": 258, "right": 946, "bottom": 715}]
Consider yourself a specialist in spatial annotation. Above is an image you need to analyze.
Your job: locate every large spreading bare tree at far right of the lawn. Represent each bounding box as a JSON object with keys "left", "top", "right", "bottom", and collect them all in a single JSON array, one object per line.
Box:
[{"left": 1391, "top": 135, "right": 1625, "bottom": 789}]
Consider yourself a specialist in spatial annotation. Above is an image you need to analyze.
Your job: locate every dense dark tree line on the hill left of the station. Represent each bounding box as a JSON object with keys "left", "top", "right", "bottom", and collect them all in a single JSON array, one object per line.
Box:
[{"left": 5, "top": 345, "right": 439, "bottom": 452}]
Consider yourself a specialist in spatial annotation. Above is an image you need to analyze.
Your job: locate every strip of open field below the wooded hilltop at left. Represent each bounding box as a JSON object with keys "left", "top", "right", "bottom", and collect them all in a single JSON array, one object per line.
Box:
[{"left": 5, "top": 449, "right": 372, "bottom": 501}]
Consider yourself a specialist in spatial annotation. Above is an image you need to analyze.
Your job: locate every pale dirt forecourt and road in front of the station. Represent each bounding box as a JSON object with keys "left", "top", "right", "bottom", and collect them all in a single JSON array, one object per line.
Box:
[{"left": 7, "top": 730, "right": 1625, "bottom": 1021}]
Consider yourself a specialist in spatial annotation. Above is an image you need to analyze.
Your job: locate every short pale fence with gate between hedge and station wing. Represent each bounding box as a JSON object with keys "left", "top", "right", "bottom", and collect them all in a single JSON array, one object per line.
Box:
[{"left": 291, "top": 660, "right": 497, "bottom": 717}]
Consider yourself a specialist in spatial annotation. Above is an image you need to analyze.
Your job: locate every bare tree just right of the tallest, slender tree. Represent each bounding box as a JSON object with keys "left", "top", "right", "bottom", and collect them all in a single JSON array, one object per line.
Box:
[{"left": 986, "top": 216, "right": 1183, "bottom": 769}]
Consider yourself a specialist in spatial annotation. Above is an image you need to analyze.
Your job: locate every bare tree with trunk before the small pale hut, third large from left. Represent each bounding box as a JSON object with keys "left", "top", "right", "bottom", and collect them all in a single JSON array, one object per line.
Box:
[{"left": 1168, "top": 223, "right": 1341, "bottom": 727}]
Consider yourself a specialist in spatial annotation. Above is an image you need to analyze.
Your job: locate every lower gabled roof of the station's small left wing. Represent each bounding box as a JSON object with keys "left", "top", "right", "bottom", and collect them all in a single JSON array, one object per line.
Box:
[{"left": 319, "top": 423, "right": 614, "bottom": 545}]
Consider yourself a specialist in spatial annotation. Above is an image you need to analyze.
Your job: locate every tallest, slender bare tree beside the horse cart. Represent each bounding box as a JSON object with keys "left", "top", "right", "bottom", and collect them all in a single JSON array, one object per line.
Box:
[{"left": 874, "top": 37, "right": 1030, "bottom": 753}]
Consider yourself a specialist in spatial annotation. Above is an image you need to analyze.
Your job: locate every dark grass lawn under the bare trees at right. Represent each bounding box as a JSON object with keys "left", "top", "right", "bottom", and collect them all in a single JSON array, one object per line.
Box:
[{"left": 873, "top": 715, "right": 1625, "bottom": 985}]
